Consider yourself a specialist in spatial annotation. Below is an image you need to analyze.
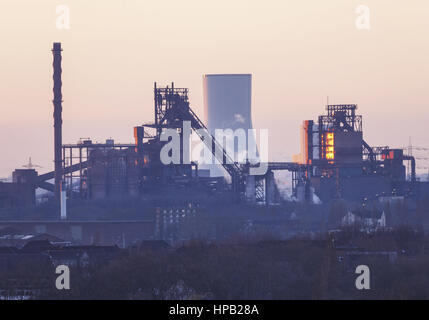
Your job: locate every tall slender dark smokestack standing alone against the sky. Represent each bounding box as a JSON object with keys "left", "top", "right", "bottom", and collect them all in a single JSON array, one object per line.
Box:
[{"left": 52, "top": 42, "right": 63, "bottom": 200}]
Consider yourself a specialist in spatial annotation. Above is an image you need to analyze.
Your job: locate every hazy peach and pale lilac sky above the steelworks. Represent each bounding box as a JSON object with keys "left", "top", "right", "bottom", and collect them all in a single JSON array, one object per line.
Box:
[{"left": 0, "top": 0, "right": 429, "bottom": 176}]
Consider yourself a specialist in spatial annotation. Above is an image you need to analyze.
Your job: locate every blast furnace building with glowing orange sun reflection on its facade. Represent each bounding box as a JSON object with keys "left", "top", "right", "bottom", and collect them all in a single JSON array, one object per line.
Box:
[{"left": 294, "top": 104, "right": 428, "bottom": 202}]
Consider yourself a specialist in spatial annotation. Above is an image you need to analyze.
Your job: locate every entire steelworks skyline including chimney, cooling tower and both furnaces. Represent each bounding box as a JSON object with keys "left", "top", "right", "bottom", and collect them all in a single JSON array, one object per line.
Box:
[{"left": 0, "top": 43, "right": 429, "bottom": 215}]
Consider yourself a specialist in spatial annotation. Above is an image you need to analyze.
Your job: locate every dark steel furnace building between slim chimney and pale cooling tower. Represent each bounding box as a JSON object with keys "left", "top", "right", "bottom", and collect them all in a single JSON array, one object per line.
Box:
[{"left": 56, "top": 83, "right": 227, "bottom": 199}]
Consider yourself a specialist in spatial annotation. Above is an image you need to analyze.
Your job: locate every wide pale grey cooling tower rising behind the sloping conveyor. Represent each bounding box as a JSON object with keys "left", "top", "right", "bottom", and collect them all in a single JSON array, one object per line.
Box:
[{"left": 203, "top": 74, "right": 254, "bottom": 176}]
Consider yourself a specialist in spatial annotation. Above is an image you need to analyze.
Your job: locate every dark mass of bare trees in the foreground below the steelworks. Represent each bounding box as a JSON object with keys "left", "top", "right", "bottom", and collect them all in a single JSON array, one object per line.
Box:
[{"left": 30, "top": 228, "right": 429, "bottom": 299}]
